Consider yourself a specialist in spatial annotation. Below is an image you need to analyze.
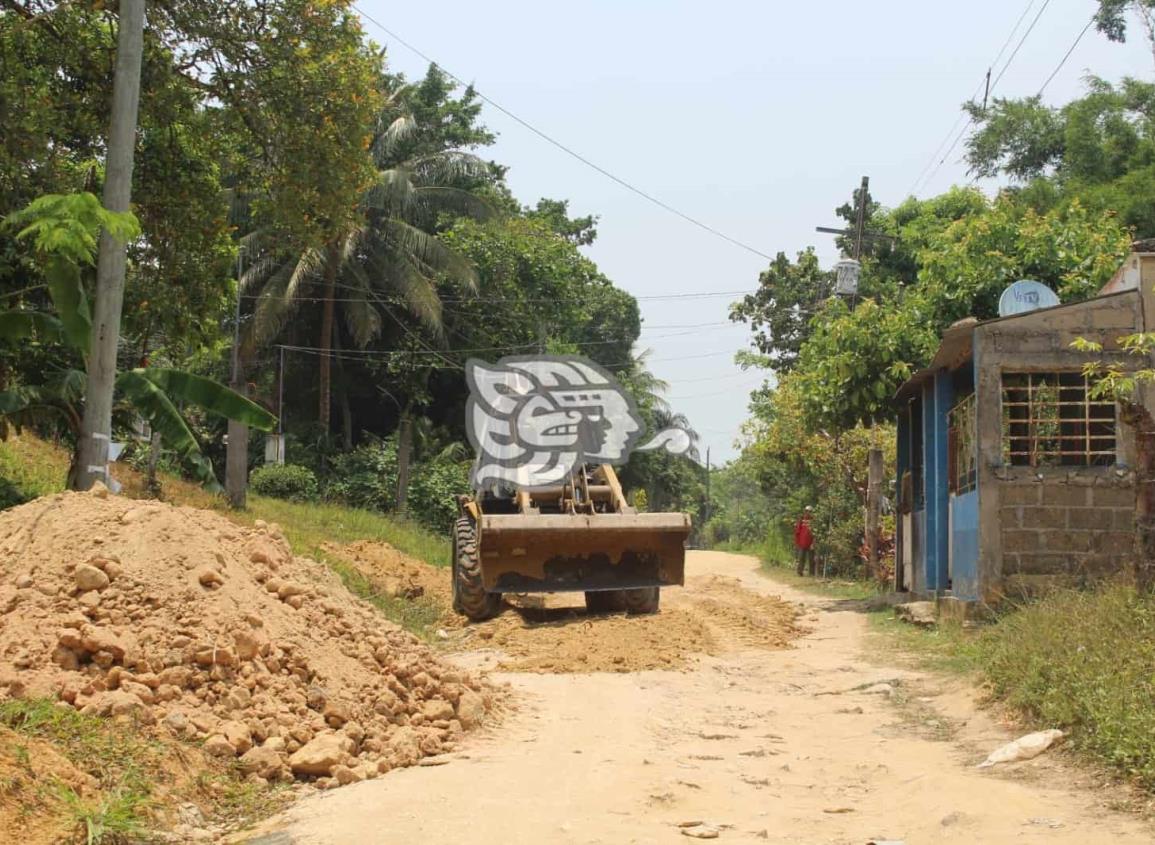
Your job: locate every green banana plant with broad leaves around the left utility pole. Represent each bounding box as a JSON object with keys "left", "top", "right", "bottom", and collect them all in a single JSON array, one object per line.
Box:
[{"left": 0, "top": 194, "right": 276, "bottom": 489}]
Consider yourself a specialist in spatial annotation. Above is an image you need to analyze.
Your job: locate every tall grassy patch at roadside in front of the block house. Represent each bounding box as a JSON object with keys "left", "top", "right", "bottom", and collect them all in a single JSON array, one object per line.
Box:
[{"left": 978, "top": 585, "right": 1155, "bottom": 788}]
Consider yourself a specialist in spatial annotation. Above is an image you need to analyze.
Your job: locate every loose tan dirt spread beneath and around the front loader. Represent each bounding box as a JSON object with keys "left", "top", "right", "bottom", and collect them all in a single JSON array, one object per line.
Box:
[{"left": 328, "top": 543, "right": 800, "bottom": 673}]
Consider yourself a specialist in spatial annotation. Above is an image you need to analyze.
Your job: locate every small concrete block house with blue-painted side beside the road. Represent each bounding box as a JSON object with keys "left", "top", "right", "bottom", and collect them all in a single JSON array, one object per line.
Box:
[{"left": 895, "top": 270, "right": 1155, "bottom": 601}]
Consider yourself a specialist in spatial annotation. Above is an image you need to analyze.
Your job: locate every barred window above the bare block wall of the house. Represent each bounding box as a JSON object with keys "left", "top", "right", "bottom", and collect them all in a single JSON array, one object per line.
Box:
[{"left": 1003, "top": 372, "right": 1116, "bottom": 466}]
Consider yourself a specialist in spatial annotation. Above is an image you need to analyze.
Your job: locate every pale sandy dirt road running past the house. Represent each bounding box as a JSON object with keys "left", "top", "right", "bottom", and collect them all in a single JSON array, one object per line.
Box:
[{"left": 252, "top": 552, "right": 1153, "bottom": 845}]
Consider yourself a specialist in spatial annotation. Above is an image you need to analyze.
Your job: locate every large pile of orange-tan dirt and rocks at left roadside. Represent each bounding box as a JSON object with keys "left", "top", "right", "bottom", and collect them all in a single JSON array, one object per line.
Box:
[{"left": 0, "top": 488, "right": 492, "bottom": 785}]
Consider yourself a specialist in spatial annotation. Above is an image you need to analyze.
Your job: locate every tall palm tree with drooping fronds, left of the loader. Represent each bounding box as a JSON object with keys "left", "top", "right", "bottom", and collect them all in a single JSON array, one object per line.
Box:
[{"left": 240, "top": 89, "right": 490, "bottom": 431}]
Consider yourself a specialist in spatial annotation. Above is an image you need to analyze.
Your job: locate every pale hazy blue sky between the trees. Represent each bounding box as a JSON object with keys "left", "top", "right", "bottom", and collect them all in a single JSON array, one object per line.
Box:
[{"left": 357, "top": 0, "right": 1155, "bottom": 465}]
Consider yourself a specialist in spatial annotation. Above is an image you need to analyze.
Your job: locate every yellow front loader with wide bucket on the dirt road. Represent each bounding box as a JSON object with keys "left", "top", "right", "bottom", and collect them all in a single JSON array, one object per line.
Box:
[{"left": 453, "top": 464, "right": 690, "bottom": 620}]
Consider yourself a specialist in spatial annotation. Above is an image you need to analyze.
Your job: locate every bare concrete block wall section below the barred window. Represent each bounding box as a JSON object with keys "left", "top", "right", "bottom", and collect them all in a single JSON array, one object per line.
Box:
[{"left": 997, "top": 473, "right": 1135, "bottom": 582}]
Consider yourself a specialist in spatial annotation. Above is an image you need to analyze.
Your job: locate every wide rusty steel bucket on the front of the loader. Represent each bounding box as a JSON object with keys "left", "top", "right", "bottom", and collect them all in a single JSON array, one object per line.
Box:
[{"left": 479, "top": 514, "right": 690, "bottom": 592}]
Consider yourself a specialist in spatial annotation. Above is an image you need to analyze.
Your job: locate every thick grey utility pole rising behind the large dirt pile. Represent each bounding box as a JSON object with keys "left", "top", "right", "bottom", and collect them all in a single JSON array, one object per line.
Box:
[{"left": 74, "top": 0, "right": 144, "bottom": 489}]
